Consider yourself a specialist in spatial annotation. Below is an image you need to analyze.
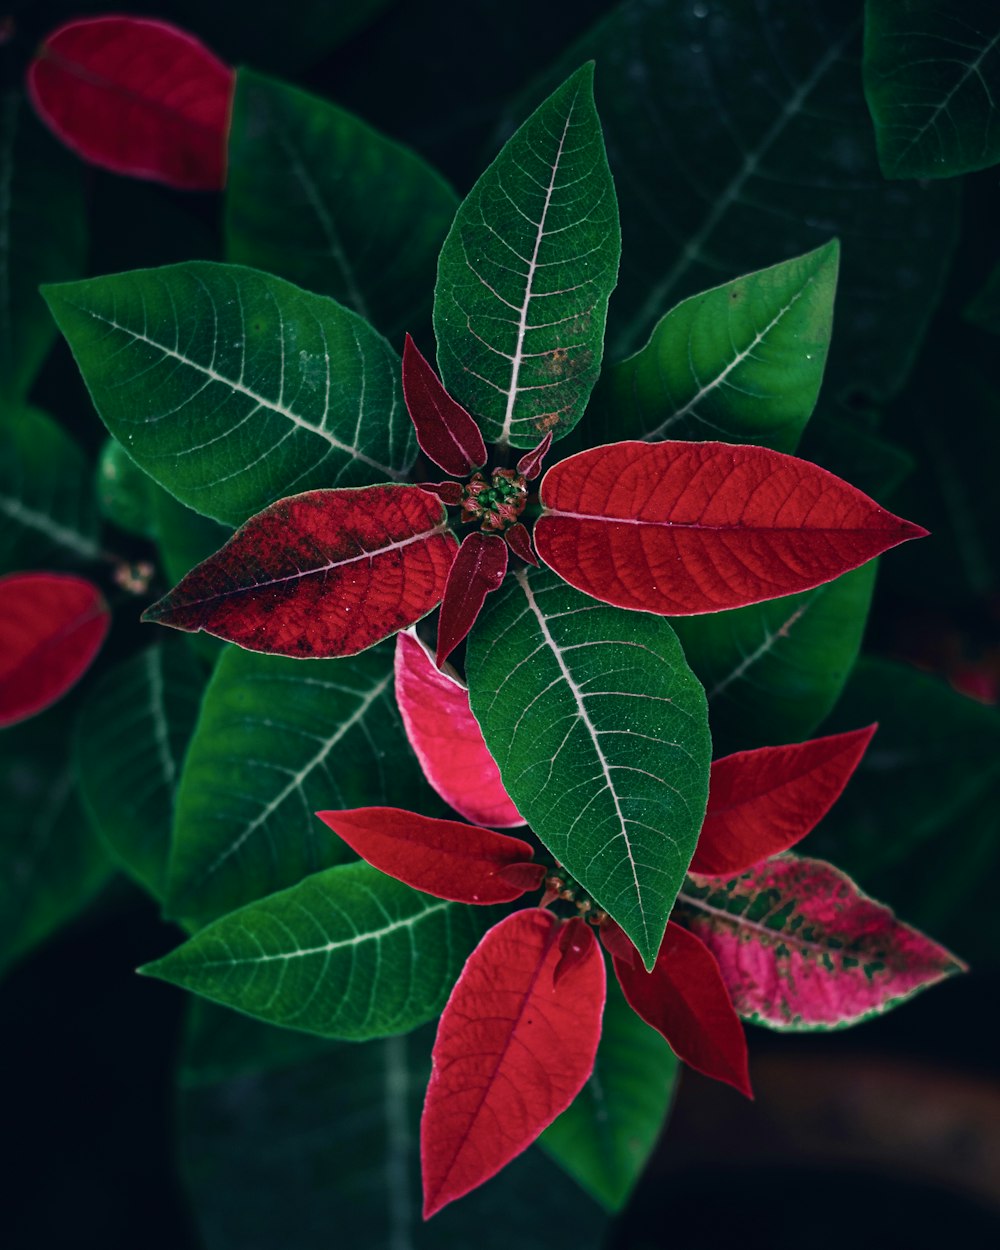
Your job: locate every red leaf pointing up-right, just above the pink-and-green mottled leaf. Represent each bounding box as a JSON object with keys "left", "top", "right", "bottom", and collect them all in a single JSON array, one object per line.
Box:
[{"left": 691, "top": 725, "right": 878, "bottom": 876}]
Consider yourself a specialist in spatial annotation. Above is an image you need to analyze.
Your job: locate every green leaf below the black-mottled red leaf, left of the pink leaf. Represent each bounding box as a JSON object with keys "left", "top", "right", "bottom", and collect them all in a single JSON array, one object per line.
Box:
[{"left": 168, "top": 644, "right": 425, "bottom": 923}]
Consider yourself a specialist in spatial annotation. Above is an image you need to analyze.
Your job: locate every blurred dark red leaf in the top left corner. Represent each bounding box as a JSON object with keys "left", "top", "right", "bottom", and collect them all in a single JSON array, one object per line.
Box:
[{"left": 28, "top": 16, "right": 234, "bottom": 191}]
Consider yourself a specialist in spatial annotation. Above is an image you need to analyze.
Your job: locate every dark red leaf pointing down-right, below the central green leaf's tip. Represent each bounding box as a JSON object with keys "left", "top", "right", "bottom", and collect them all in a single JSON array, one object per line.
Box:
[{"left": 614, "top": 920, "right": 754, "bottom": 1098}]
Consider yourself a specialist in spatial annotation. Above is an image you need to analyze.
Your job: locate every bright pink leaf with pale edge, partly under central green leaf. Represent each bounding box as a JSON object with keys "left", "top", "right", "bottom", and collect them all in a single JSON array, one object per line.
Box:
[{"left": 396, "top": 633, "right": 524, "bottom": 829}]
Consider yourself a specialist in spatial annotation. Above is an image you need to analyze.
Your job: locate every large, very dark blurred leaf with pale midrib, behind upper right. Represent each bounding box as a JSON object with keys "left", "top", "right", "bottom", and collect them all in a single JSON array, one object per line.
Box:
[{"left": 533, "top": 0, "right": 958, "bottom": 395}]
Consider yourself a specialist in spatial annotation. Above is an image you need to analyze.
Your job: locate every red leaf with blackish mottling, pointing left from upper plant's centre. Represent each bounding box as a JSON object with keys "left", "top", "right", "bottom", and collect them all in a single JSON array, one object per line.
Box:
[{"left": 143, "top": 485, "right": 456, "bottom": 659}]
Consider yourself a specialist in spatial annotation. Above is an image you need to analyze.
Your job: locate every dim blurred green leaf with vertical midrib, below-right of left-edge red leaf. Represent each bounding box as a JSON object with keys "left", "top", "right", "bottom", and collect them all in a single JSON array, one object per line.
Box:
[{"left": 75, "top": 639, "right": 205, "bottom": 899}]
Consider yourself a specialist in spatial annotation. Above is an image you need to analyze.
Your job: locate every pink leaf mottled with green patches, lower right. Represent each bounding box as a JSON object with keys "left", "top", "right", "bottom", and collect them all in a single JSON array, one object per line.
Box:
[{"left": 674, "top": 855, "right": 965, "bottom": 1031}]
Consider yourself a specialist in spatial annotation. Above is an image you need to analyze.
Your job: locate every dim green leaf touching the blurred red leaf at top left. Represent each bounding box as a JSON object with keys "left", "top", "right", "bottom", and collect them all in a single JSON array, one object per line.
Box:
[{"left": 226, "top": 70, "right": 458, "bottom": 345}]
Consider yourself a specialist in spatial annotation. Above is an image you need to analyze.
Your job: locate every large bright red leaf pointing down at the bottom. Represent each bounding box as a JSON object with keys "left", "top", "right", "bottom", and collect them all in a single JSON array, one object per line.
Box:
[{"left": 420, "top": 908, "right": 605, "bottom": 1219}]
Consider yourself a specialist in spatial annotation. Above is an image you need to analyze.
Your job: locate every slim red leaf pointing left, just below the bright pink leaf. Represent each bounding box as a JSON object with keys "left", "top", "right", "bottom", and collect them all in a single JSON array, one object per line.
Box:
[{"left": 316, "top": 808, "right": 541, "bottom": 903}]
